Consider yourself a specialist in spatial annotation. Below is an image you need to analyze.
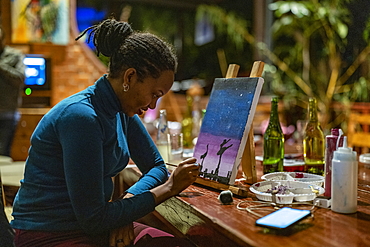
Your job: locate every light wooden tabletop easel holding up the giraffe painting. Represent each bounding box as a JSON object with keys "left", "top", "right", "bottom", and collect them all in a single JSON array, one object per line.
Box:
[{"left": 195, "top": 61, "right": 265, "bottom": 197}]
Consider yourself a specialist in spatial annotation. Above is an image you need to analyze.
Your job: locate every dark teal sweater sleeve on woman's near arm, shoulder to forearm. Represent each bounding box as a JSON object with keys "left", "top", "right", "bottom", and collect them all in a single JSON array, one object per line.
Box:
[{"left": 56, "top": 104, "right": 155, "bottom": 233}]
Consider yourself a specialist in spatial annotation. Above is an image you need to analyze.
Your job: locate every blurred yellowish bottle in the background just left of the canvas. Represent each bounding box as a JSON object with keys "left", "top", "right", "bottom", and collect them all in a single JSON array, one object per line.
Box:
[{"left": 181, "top": 95, "right": 193, "bottom": 148}]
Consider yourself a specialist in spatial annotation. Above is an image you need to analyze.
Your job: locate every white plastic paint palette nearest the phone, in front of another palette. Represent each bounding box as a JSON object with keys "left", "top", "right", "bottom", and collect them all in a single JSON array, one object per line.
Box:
[{"left": 249, "top": 180, "right": 325, "bottom": 204}]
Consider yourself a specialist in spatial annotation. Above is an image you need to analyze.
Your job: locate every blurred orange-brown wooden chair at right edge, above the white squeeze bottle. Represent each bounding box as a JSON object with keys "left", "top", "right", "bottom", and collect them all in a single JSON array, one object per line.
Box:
[{"left": 347, "top": 113, "right": 370, "bottom": 154}]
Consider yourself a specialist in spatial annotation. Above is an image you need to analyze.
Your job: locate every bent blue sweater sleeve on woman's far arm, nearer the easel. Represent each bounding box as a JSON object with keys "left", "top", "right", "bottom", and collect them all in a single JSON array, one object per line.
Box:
[{"left": 127, "top": 115, "right": 168, "bottom": 195}]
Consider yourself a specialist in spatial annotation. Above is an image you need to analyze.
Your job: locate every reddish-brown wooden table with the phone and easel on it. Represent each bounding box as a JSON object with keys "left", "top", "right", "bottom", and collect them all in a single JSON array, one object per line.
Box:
[{"left": 152, "top": 160, "right": 370, "bottom": 247}]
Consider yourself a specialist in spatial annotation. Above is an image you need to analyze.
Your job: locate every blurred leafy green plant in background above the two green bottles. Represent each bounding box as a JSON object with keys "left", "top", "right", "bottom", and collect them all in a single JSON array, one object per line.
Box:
[{"left": 197, "top": 0, "right": 370, "bottom": 132}]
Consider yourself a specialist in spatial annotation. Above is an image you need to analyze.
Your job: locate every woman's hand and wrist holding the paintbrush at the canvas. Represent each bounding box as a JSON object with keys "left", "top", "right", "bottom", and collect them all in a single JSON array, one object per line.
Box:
[{"left": 150, "top": 158, "right": 199, "bottom": 205}]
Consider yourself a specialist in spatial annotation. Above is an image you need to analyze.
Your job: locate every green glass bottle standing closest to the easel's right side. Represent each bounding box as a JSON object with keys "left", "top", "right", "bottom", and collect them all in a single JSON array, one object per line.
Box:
[{"left": 263, "top": 97, "right": 284, "bottom": 174}]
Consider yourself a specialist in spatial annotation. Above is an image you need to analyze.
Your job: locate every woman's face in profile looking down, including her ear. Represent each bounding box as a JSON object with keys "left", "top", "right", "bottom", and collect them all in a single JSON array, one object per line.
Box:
[{"left": 121, "top": 69, "right": 174, "bottom": 117}]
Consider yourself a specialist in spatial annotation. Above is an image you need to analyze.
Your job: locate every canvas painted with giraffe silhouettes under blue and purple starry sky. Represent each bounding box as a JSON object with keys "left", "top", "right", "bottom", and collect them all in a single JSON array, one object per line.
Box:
[{"left": 194, "top": 77, "right": 264, "bottom": 185}]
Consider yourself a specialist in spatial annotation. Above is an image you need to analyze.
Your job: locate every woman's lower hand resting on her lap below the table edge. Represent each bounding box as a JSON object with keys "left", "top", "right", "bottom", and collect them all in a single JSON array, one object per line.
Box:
[{"left": 109, "top": 223, "right": 135, "bottom": 247}]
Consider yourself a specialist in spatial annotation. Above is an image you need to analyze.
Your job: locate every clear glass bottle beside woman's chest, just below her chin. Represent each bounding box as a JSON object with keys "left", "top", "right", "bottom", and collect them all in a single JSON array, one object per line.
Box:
[{"left": 156, "top": 109, "right": 171, "bottom": 163}]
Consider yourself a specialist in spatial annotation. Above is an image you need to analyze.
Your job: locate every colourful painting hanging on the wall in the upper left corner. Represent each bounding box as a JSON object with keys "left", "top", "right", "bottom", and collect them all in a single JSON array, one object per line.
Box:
[{"left": 11, "top": 0, "right": 69, "bottom": 45}]
